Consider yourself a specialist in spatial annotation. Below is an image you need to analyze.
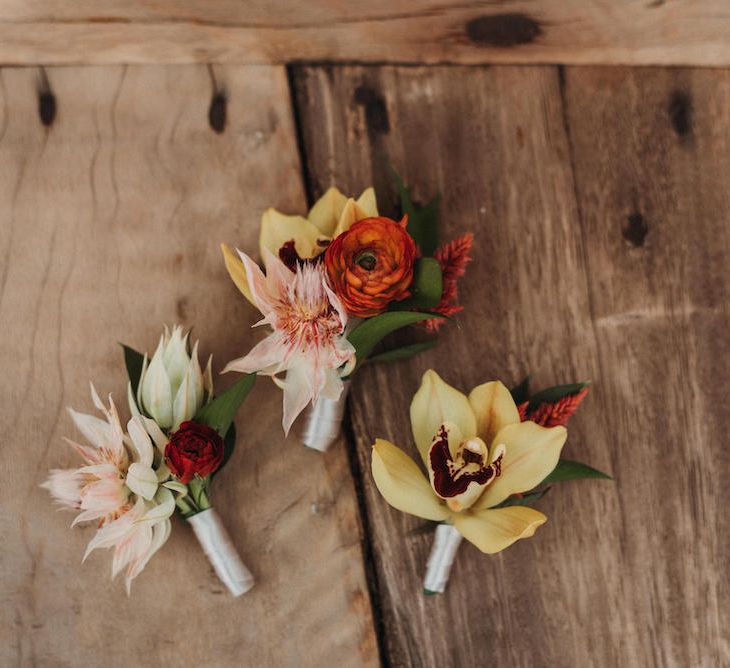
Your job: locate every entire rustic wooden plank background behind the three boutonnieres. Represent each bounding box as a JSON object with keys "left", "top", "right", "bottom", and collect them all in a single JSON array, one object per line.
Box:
[{"left": 0, "top": 5, "right": 730, "bottom": 668}]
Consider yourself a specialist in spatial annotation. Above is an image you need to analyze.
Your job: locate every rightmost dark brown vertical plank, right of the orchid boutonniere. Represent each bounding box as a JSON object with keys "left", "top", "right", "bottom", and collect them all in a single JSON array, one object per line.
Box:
[{"left": 565, "top": 68, "right": 730, "bottom": 666}]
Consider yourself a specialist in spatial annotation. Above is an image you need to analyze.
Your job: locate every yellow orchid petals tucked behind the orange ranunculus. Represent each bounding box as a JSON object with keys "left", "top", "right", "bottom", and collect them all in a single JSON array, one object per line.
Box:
[{"left": 221, "top": 186, "right": 378, "bottom": 304}]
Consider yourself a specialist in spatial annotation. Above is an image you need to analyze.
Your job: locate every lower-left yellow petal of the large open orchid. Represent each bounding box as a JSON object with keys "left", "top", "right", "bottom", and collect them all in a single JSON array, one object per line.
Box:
[{"left": 372, "top": 439, "right": 449, "bottom": 521}]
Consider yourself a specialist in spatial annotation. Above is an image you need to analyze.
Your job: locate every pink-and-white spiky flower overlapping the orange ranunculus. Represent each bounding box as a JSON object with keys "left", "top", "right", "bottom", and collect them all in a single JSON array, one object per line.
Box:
[{"left": 223, "top": 251, "right": 355, "bottom": 433}]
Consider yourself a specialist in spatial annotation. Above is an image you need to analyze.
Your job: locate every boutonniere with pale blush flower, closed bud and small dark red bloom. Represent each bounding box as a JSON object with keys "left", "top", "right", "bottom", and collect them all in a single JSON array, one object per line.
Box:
[{"left": 43, "top": 327, "right": 255, "bottom": 596}]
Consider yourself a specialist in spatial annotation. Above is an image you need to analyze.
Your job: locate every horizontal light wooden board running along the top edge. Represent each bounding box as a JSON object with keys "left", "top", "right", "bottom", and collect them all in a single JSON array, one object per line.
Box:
[{"left": 0, "top": 0, "right": 730, "bottom": 65}]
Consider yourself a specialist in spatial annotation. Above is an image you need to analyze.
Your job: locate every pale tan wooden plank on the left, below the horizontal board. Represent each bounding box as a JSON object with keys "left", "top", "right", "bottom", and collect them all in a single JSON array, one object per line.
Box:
[{"left": 0, "top": 66, "right": 378, "bottom": 666}]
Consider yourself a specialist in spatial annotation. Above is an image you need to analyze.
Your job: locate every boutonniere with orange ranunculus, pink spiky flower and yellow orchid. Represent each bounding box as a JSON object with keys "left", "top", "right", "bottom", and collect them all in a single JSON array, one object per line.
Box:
[{"left": 222, "top": 178, "right": 472, "bottom": 450}]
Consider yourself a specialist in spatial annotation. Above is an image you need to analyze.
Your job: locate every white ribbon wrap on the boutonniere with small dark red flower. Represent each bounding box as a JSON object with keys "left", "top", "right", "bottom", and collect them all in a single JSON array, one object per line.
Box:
[{"left": 188, "top": 508, "right": 254, "bottom": 596}]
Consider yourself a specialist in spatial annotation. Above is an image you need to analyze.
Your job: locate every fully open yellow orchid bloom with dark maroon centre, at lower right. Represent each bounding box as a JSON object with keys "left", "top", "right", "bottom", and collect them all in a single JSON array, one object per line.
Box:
[{"left": 372, "top": 370, "right": 568, "bottom": 554}]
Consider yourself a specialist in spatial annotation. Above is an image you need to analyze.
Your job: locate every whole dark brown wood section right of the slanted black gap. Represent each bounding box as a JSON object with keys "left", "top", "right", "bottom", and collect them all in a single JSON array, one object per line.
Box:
[{"left": 294, "top": 67, "right": 730, "bottom": 666}]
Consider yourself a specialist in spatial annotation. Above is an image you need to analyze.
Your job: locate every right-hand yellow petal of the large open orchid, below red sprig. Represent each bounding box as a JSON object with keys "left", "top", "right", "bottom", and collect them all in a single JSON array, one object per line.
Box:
[{"left": 474, "top": 422, "right": 568, "bottom": 509}]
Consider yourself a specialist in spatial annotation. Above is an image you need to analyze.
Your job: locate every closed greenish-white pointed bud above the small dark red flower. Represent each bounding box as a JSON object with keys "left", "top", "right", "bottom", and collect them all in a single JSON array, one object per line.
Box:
[{"left": 137, "top": 326, "right": 213, "bottom": 431}]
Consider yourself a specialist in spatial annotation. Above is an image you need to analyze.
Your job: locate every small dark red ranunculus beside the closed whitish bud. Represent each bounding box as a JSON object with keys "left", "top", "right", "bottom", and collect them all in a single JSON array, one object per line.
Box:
[{"left": 165, "top": 420, "right": 225, "bottom": 485}]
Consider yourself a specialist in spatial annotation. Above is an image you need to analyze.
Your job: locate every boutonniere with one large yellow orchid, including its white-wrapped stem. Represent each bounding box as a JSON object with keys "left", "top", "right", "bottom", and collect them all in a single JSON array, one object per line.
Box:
[{"left": 372, "top": 370, "right": 610, "bottom": 593}]
